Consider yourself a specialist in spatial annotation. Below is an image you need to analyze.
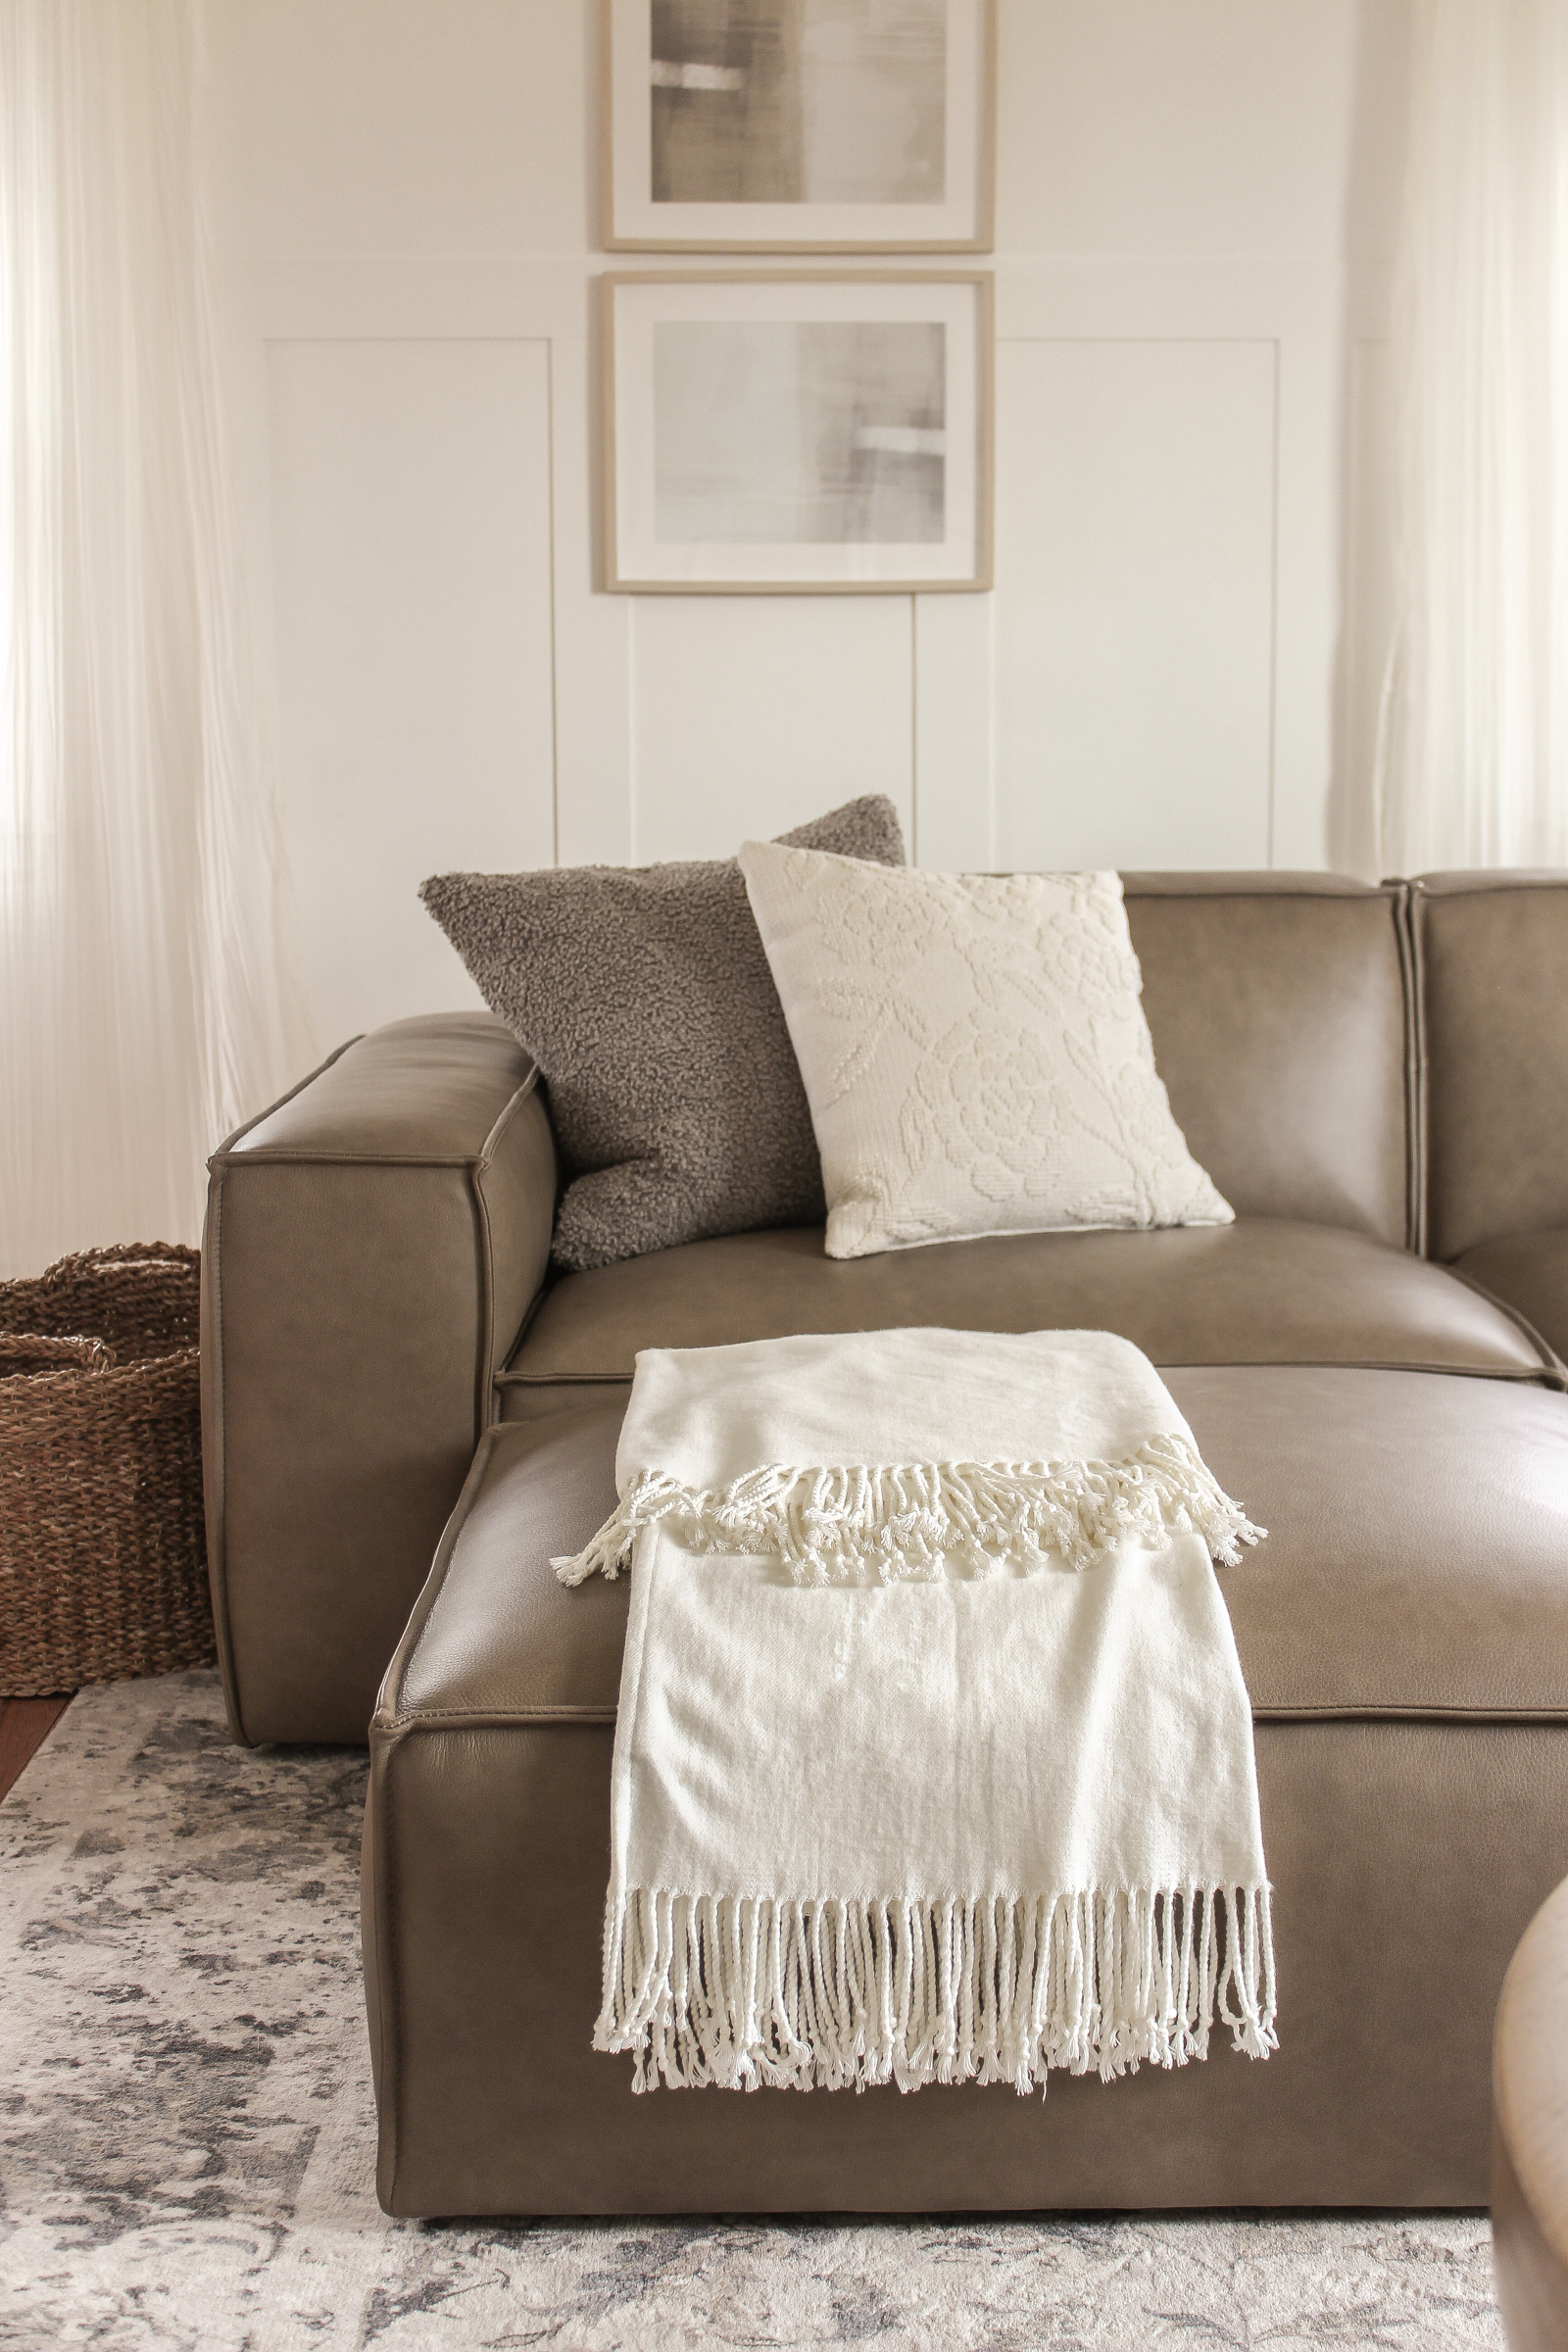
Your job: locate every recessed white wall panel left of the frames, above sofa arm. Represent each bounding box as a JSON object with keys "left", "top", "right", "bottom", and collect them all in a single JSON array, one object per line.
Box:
[{"left": 266, "top": 336, "right": 555, "bottom": 1045}]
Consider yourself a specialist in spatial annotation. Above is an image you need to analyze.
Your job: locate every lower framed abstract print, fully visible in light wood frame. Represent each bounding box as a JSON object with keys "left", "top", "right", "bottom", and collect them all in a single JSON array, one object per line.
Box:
[{"left": 600, "top": 270, "right": 992, "bottom": 595}]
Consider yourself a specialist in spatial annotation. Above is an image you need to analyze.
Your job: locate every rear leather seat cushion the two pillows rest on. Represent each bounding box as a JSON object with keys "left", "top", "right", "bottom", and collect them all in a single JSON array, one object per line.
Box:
[{"left": 501, "top": 1218, "right": 1556, "bottom": 1418}]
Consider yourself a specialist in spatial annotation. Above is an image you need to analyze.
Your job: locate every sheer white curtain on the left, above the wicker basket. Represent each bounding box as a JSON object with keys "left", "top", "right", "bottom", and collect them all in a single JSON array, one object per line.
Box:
[{"left": 0, "top": 0, "right": 308, "bottom": 1275}]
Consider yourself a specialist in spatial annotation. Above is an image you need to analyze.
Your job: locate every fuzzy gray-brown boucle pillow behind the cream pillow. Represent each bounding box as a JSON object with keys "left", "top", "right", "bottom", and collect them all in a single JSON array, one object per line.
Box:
[{"left": 418, "top": 795, "right": 903, "bottom": 1270}]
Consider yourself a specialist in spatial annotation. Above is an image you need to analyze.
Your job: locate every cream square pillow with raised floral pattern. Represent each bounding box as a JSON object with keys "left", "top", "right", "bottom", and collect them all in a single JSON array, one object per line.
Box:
[{"left": 741, "top": 842, "right": 1232, "bottom": 1258}]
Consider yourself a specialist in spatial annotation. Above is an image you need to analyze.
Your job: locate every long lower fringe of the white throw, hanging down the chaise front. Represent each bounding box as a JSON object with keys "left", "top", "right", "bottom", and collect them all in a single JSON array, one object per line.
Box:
[{"left": 595, "top": 1884, "right": 1279, "bottom": 2093}]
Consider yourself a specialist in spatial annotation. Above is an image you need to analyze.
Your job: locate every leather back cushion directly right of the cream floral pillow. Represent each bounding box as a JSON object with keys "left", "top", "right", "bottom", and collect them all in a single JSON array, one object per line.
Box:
[{"left": 1121, "top": 875, "right": 1415, "bottom": 1247}]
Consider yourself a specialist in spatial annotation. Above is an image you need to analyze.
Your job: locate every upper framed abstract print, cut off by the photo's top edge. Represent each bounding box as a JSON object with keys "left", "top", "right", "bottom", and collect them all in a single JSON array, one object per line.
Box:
[{"left": 602, "top": 0, "right": 997, "bottom": 254}]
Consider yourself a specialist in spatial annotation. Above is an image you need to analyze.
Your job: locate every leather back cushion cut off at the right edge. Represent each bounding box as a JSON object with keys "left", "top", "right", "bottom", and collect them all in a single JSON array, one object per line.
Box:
[{"left": 1429, "top": 872, "right": 1568, "bottom": 1258}]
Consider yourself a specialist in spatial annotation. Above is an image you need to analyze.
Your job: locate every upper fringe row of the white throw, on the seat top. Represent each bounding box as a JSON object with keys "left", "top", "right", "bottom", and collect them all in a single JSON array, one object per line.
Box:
[{"left": 550, "top": 1435, "right": 1265, "bottom": 1586}]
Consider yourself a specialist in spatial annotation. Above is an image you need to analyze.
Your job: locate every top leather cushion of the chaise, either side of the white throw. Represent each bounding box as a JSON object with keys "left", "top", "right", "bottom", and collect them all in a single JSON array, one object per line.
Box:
[{"left": 385, "top": 1364, "right": 1568, "bottom": 1724}]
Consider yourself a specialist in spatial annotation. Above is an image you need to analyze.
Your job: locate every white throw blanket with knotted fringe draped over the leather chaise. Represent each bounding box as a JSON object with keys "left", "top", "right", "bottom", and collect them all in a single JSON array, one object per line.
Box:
[{"left": 555, "top": 1331, "right": 1274, "bottom": 2091}]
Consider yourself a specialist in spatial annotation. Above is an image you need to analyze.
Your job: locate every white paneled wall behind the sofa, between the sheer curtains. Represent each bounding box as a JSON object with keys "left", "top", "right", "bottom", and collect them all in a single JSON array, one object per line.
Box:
[{"left": 212, "top": 0, "right": 1405, "bottom": 1042}]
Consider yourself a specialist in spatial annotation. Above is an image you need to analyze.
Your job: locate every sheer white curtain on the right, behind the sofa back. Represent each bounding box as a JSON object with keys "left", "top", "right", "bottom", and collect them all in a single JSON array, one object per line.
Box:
[{"left": 1378, "top": 0, "right": 1568, "bottom": 872}]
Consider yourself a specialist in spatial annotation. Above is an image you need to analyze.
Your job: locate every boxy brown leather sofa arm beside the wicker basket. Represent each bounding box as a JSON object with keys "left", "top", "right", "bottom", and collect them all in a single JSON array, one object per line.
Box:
[{"left": 202, "top": 1013, "right": 555, "bottom": 1745}]
